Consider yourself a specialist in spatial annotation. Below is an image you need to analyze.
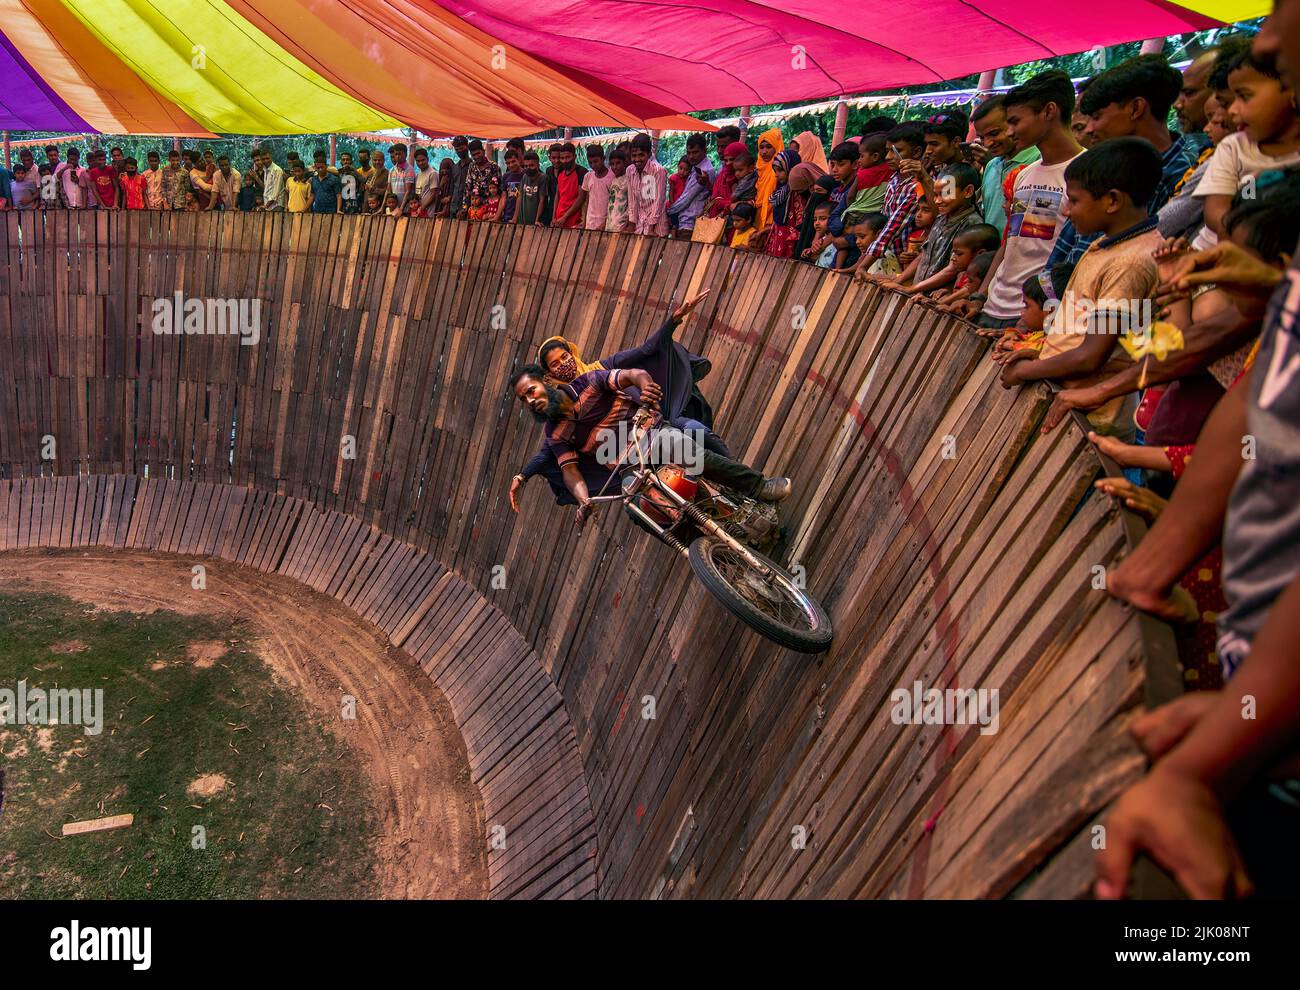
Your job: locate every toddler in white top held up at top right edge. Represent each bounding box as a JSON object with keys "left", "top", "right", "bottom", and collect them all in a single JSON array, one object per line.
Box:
[{"left": 1192, "top": 48, "right": 1300, "bottom": 251}]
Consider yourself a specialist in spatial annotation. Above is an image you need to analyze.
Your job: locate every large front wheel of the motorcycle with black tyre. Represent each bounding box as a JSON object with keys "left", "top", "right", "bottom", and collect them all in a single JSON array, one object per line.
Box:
[{"left": 690, "top": 537, "right": 833, "bottom": 654}]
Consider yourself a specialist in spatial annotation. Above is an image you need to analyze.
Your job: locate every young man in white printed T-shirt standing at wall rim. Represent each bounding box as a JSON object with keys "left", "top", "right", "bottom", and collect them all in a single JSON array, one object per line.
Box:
[{"left": 965, "top": 69, "right": 1083, "bottom": 330}]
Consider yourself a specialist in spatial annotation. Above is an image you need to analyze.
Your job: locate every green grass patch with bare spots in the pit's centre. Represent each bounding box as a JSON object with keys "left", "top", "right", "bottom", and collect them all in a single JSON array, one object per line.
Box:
[{"left": 0, "top": 594, "right": 378, "bottom": 899}]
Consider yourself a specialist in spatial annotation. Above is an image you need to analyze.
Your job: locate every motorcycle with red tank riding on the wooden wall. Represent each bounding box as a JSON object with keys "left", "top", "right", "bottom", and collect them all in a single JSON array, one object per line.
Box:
[{"left": 577, "top": 407, "right": 833, "bottom": 654}]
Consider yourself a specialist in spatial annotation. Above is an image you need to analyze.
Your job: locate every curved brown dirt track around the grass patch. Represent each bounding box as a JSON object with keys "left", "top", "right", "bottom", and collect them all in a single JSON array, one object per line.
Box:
[{"left": 0, "top": 548, "right": 488, "bottom": 898}]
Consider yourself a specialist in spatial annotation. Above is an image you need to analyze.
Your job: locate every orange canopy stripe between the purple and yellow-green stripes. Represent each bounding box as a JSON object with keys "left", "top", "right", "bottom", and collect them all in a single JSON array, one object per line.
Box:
[{"left": 0, "top": 0, "right": 216, "bottom": 138}]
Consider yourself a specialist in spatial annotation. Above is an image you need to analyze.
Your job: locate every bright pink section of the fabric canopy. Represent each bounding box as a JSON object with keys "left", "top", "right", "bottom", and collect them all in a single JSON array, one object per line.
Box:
[{"left": 437, "top": 0, "right": 1222, "bottom": 110}]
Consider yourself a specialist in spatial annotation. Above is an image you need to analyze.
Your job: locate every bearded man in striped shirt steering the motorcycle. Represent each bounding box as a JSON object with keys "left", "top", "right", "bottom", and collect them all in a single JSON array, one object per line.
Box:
[{"left": 510, "top": 364, "right": 790, "bottom": 529}]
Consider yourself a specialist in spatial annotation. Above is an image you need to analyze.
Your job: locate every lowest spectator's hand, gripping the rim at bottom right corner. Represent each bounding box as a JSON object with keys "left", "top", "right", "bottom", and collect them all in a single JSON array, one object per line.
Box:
[{"left": 1096, "top": 764, "right": 1252, "bottom": 900}]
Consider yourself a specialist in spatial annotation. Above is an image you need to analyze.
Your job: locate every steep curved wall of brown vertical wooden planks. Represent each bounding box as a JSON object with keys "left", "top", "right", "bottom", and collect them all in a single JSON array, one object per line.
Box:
[{"left": 0, "top": 213, "right": 1171, "bottom": 896}]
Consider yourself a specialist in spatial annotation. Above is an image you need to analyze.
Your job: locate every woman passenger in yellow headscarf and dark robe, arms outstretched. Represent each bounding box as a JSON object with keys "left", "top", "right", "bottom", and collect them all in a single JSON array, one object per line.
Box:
[{"left": 510, "top": 288, "right": 731, "bottom": 512}]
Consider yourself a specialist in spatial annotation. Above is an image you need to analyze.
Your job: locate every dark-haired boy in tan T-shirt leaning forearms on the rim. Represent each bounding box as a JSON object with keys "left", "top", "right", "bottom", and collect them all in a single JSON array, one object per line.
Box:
[{"left": 1002, "top": 138, "right": 1162, "bottom": 437}]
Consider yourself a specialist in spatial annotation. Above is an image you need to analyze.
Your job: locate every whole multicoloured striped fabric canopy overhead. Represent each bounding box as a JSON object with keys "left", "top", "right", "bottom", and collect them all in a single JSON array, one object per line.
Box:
[{"left": 0, "top": 0, "right": 1269, "bottom": 136}]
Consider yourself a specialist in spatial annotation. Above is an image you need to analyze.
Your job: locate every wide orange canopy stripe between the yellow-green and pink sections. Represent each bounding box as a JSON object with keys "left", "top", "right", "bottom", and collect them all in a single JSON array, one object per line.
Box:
[{"left": 226, "top": 0, "right": 709, "bottom": 135}]
